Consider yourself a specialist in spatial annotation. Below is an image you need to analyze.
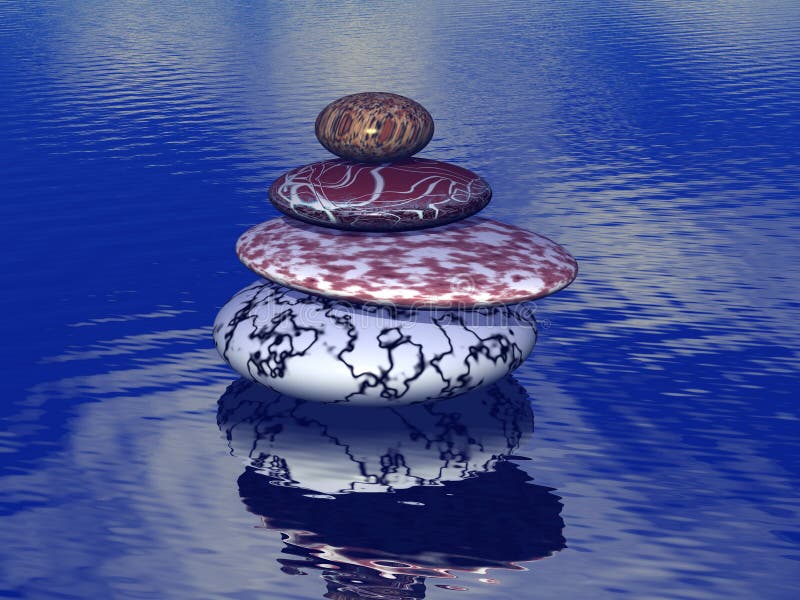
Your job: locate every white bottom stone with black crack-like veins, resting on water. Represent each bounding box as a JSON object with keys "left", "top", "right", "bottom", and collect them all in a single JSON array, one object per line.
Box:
[{"left": 214, "top": 280, "right": 536, "bottom": 405}]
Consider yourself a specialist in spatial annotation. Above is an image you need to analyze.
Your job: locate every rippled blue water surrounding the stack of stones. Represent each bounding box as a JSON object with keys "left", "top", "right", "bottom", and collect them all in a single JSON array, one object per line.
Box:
[{"left": 0, "top": 0, "right": 800, "bottom": 599}]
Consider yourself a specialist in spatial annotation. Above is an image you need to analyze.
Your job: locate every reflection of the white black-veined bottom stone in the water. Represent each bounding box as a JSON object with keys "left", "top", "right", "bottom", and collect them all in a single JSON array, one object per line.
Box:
[{"left": 217, "top": 376, "right": 533, "bottom": 495}]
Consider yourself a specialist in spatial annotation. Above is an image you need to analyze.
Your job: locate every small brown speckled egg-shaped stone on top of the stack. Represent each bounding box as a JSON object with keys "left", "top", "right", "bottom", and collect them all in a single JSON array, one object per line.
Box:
[{"left": 314, "top": 92, "right": 433, "bottom": 162}]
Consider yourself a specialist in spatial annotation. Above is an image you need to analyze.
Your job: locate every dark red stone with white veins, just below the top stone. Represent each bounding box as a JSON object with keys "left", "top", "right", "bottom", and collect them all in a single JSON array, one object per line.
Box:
[{"left": 269, "top": 158, "right": 492, "bottom": 231}]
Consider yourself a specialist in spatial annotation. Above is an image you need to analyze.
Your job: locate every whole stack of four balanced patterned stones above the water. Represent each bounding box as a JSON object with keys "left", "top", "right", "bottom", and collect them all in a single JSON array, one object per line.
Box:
[{"left": 214, "top": 92, "right": 577, "bottom": 405}]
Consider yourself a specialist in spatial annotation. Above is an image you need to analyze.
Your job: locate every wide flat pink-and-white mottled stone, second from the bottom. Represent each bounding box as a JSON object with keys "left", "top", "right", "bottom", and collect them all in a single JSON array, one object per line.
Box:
[{"left": 236, "top": 217, "right": 578, "bottom": 307}]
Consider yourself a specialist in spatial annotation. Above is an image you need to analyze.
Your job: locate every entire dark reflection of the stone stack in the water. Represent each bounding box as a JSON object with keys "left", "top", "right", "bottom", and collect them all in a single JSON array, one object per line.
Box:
[{"left": 218, "top": 377, "right": 565, "bottom": 598}]
